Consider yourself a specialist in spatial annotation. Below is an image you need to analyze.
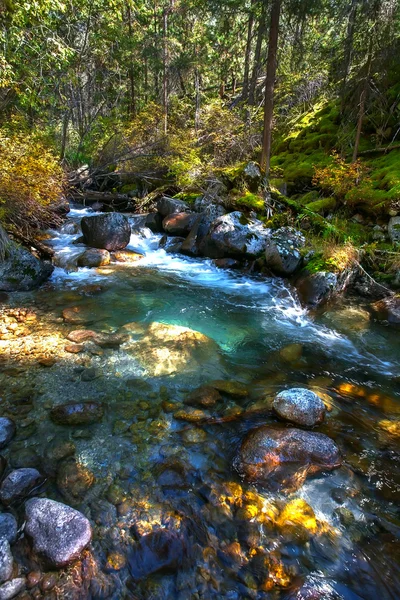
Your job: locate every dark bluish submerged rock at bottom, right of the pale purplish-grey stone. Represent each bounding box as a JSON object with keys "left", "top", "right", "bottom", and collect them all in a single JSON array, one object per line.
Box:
[{"left": 128, "top": 529, "right": 185, "bottom": 581}]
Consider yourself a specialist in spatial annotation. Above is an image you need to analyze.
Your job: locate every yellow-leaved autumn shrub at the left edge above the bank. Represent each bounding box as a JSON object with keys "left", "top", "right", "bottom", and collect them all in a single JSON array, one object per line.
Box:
[{"left": 0, "top": 129, "right": 64, "bottom": 234}]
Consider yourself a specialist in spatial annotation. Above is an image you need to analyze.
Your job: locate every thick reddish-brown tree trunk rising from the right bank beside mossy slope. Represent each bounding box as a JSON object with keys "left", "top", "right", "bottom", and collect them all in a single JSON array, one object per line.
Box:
[{"left": 260, "top": 0, "right": 281, "bottom": 177}]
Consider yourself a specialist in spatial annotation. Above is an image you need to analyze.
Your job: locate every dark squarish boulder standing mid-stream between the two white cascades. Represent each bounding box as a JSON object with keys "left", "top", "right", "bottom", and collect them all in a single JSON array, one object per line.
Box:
[{"left": 81, "top": 213, "right": 131, "bottom": 251}]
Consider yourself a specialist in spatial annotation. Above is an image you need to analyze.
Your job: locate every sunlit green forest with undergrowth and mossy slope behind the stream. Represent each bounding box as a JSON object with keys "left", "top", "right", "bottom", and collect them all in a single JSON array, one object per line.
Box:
[{"left": 0, "top": 0, "right": 400, "bottom": 280}]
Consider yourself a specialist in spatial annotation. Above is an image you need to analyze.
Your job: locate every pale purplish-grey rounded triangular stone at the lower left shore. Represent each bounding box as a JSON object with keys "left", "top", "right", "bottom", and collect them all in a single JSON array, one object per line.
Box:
[{"left": 25, "top": 498, "right": 92, "bottom": 568}]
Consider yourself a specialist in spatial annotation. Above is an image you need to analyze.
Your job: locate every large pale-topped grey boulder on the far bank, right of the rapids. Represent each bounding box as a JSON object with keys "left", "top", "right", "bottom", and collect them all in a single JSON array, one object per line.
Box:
[{"left": 201, "top": 211, "right": 271, "bottom": 258}]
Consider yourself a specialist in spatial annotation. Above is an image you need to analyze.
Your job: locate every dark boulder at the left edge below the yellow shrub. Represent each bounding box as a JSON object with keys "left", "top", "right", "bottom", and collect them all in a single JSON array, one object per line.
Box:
[{"left": 0, "top": 225, "right": 54, "bottom": 292}]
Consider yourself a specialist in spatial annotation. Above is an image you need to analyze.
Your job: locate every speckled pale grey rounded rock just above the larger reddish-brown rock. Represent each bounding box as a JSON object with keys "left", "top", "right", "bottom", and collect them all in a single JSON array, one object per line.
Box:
[{"left": 272, "top": 388, "right": 326, "bottom": 427}]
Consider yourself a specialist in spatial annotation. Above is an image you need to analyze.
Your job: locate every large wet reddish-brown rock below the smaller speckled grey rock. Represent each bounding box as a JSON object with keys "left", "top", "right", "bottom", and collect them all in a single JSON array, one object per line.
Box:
[{"left": 236, "top": 426, "right": 342, "bottom": 492}]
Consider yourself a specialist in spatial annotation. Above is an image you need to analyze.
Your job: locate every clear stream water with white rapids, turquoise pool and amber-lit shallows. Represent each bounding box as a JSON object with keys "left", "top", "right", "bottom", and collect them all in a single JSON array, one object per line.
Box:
[{"left": 0, "top": 208, "right": 400, "bottom": 600}]
